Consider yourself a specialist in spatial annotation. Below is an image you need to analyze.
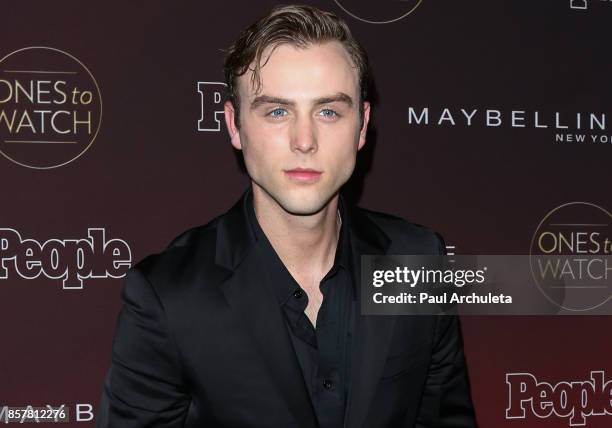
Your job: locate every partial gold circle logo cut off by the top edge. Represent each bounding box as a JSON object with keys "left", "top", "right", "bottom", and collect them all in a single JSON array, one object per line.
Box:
[{"left": 334, "top": 0, "right": 423, "bottom": 24}]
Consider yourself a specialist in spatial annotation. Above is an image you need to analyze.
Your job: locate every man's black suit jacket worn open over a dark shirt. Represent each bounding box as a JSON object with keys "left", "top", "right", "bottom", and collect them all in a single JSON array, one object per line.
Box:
[{"left": 97, "top": 191, "right": 476, "bottom": 428}]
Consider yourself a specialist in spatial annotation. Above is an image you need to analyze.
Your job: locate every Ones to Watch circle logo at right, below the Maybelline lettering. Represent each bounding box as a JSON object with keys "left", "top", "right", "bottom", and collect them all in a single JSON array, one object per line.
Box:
[{"left": 529, "top": 202, "right": 612, "bottom": 312}]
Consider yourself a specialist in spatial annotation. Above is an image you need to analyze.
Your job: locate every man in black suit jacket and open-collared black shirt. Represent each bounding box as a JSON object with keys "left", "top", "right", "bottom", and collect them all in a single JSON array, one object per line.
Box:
[{"left": 98, "top": 6, "right": 475, "bottom": 428}]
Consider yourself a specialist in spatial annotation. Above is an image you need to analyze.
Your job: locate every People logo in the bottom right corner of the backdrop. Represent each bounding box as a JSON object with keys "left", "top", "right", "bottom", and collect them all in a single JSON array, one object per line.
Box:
[{"left": 506, "top": 371, "right": 612, "bottom": 427}]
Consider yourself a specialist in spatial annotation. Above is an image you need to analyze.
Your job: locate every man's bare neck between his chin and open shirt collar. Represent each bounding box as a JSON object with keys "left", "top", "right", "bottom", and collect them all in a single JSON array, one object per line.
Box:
[{"left": 253, "top": 184, "right": 340, "bottom": 280}]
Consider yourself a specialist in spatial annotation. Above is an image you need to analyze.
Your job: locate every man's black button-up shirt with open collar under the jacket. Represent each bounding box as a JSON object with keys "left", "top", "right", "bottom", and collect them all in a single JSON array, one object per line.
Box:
[{"left": 247, "top": 194, "right": 356, "bottom": 428}]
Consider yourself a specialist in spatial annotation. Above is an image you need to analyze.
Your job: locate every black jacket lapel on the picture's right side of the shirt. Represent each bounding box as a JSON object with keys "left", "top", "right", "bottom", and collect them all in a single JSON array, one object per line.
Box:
[{"left": 345, "top": 205, "right": 396, "bottom": 428}]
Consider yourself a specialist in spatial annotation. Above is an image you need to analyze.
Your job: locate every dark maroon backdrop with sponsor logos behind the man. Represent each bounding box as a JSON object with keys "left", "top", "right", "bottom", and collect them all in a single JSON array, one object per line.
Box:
[{"left": 0, "top": 0, "right": 612, "bottom": 428}]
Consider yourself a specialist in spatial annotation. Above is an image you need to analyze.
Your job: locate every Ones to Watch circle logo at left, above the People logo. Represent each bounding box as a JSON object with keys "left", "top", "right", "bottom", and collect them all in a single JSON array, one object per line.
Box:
[{"left": 0, "top": 46, "right": 102, "bottom": 169}]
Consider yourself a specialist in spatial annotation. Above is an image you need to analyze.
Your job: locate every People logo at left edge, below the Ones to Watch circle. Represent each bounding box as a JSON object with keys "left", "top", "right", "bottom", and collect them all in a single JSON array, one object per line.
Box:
[{"left": 0, "top": 228, "right": 132, "bottom": 289}]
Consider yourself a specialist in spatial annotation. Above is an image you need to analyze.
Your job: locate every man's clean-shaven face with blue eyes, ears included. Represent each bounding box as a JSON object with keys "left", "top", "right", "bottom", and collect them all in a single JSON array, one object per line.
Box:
[{"left": 225, "top": 41, "right": 370, "bottom": 215}]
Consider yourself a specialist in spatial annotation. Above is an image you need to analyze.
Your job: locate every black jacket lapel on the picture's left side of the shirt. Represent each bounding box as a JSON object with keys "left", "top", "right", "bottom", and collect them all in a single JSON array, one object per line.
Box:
[{"left": 216, "top": 191, "right": 317, "bottom": 428}]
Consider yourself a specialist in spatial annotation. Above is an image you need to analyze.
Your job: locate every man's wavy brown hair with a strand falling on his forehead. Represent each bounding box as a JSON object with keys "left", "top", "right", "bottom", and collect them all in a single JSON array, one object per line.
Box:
[{"left": 223, "top": 5, "right": 370, "bottom": 126}]
